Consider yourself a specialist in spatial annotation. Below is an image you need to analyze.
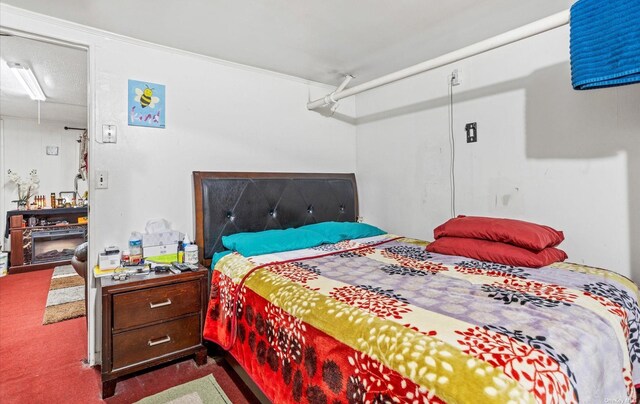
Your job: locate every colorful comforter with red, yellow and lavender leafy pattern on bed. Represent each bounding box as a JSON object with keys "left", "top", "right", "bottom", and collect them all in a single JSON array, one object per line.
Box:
[{"left": 205, "top": 235, "right": 640, "bottom": 403}]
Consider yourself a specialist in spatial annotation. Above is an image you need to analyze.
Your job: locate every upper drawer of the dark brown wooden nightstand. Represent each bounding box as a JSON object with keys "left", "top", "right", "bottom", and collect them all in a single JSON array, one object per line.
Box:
[{"left": 113, "top": 281, "right": 200, "bottom": 330}]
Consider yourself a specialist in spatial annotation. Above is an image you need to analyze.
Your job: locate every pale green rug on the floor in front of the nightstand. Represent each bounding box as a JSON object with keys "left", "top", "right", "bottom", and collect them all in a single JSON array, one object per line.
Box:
[{"left": 138, "top": 375, "right": 231, "bottom": 404}]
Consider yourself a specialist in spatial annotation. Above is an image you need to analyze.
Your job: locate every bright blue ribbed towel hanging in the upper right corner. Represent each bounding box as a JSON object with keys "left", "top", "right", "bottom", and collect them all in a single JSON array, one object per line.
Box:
[{"left": 571, "top": 0, "right": 640, "bottom": 90}]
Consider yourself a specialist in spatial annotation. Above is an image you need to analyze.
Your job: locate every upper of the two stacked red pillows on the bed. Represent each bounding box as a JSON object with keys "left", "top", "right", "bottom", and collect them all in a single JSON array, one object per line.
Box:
[{"left": 433, "top": 216, "right": 564, "bottom": 251}]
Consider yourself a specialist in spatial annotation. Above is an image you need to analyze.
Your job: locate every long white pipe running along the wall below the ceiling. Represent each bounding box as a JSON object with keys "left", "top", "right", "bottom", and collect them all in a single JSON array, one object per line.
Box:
[{"left": 307, "top": 10, "right": 570, "bottom": 110}]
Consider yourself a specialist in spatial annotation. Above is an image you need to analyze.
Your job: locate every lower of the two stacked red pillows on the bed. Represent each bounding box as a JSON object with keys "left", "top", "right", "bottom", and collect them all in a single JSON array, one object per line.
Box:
[{"left": 427, "top": 237, "right": 567, "bottom": 268}]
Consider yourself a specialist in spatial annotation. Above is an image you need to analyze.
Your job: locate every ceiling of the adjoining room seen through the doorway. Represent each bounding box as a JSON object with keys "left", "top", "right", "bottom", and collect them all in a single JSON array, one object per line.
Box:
[{"left": 0, "top": 35, "right": 87, "bottom": 125}]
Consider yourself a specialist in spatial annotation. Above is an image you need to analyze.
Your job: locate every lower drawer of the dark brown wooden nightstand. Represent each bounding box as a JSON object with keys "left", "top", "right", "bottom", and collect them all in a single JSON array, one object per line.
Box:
[{"left": 113, "top": 314, "right": 200, "bottom": 370}]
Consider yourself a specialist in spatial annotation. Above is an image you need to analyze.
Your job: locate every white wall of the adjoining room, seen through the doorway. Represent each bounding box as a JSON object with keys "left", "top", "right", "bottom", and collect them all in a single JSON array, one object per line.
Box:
[{"left": 0, "top": 116, "right": 87, "bottom": 243}]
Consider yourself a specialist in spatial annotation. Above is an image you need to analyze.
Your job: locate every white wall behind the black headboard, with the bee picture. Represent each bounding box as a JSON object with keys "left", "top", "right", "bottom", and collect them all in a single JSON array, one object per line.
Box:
[{"left": 0, "top": 4, "right": 355, "bottom": 361}]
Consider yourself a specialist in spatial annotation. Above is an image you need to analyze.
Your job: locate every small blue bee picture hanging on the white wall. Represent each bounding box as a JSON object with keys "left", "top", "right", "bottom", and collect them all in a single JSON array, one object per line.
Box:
[{"left": 128, "top": 80, "right": 166, "bottom": 128}]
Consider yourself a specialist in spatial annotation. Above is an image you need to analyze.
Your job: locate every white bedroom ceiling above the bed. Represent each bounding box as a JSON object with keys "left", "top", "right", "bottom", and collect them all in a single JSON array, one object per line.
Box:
[{"left": 1, "top": 0, "right": 573, "bottom": 85}]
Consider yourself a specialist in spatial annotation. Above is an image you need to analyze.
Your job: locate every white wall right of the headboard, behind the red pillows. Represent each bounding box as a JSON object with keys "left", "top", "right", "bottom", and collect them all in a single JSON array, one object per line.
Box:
[{"left": 356, "top": 27, "right": 640, "bottom": 281}]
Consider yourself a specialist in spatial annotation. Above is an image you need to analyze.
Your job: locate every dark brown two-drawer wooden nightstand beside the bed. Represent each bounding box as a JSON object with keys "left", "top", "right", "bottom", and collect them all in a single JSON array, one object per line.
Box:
[{"left": 101, "top": 267, "right": 208, "bottom": 398}]
